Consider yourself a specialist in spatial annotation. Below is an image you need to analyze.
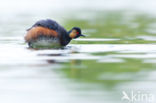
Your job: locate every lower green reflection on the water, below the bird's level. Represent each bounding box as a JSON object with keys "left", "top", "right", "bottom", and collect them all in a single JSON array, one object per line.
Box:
[{"left": 62, "top": 59, "right": 155, "bottom": 84}]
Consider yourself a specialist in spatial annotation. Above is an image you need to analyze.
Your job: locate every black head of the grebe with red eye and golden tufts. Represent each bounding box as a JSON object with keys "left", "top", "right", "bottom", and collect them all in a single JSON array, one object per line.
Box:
[{"left": 69, "top": 27, "right": 85, "bottom": 39}]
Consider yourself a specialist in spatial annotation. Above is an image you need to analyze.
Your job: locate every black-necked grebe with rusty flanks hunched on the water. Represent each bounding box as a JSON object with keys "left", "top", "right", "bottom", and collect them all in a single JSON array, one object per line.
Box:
[{"left": 24, "top": 19, "right": 85, "bottom": 48}]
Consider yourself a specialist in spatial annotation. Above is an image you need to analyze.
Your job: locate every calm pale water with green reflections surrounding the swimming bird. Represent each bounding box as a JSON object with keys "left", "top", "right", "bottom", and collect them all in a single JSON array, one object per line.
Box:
[{"left": 0, "top": 0, "right": 156, "bottom": 103}]
